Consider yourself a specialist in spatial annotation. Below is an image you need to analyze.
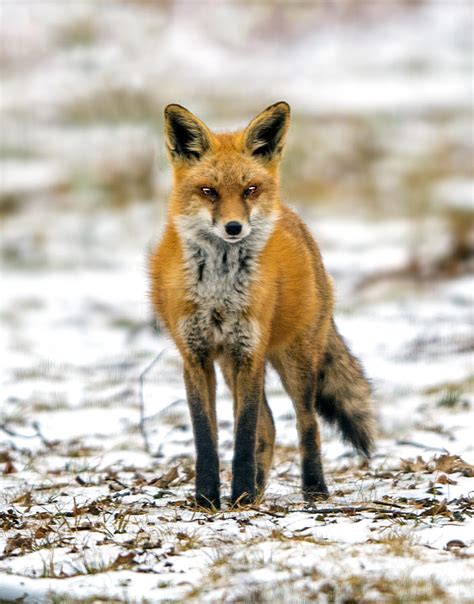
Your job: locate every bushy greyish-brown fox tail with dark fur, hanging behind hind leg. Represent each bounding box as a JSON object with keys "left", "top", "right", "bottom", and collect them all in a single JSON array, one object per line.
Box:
[{"left": 316, "top": 322, "right": 375, "bottom": 457}]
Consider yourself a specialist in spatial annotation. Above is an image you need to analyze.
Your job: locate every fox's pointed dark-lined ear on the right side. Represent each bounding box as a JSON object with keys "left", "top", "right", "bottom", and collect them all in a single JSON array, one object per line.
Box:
[{"left": 244, "top": 101, "right": 290, "bottom": 162}]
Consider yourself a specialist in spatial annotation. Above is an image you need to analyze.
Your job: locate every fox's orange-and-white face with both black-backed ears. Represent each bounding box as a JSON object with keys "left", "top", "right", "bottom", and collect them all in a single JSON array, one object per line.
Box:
[{"left": 165, "top": 101, "right": 290, "bottom": 243}]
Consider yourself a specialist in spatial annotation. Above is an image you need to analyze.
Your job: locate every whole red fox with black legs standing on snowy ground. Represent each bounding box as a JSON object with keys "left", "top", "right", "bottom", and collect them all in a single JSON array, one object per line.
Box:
[{"left": 150, "top": 102, "right": 374, "bottom": 508}]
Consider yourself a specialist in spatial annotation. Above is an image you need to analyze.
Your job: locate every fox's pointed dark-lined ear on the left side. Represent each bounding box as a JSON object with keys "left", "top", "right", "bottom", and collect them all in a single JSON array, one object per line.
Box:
[{"left": 165, "top": 104, "right": 211, "bottom": 161}]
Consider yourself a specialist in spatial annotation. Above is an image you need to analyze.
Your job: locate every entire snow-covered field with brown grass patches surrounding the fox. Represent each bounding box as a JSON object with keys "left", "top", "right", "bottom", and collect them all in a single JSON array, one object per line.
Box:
[{"left": 0, "top": 0, "right": 474, "bottom": 603}]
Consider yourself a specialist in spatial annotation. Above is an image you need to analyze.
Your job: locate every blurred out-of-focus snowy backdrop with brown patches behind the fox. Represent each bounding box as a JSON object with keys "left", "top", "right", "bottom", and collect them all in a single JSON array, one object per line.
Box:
[{"left": 0, "top": 0, "right": 474, "bottom": 462}]
